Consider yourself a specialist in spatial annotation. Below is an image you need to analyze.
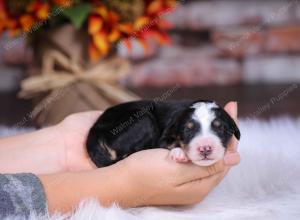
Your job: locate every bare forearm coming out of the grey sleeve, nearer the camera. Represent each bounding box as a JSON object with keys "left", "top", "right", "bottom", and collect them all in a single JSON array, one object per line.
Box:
[{"left": 39, "top": 166, "right": 135, "bottom": 213}]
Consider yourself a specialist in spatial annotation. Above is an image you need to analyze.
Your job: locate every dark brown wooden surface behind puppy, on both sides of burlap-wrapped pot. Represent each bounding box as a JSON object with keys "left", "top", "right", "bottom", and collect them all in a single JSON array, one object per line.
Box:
[{"left": 0, "top": 84, "right": 300, "bottom": 126}]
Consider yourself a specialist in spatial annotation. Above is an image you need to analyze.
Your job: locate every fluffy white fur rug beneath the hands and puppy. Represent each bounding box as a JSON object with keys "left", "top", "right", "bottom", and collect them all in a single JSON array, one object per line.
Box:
[{"left": 2, "top": 118, "right": 300, "bottom": 220}]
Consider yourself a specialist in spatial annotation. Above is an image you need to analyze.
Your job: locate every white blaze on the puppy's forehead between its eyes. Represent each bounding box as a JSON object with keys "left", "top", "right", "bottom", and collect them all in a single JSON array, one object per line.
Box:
[{"left": 191, "top": 102, "right": 218, "bottom": 135}]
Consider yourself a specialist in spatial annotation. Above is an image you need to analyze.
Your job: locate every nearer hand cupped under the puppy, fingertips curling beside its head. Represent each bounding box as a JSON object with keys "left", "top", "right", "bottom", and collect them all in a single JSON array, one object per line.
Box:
[{"left": 110, "top": 102, "right": 240, "bottom": 207}]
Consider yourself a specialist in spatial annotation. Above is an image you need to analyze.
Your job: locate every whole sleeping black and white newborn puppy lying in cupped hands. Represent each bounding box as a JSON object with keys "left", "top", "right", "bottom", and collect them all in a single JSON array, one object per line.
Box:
[{"left": 86, "top": 100, "right": 240, "bottom": 167}]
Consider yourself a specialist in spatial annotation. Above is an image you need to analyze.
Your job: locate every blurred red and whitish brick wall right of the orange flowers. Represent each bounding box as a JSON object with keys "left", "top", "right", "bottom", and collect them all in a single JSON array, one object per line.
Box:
[{"left": 127, "top": 0, "right": 300, "bottom": 86}]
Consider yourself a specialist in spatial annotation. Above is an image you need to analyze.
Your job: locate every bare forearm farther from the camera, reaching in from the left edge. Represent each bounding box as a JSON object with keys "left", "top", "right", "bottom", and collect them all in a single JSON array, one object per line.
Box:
[{"left": 0, "top": 127, "right": 65, "bottom": 174}]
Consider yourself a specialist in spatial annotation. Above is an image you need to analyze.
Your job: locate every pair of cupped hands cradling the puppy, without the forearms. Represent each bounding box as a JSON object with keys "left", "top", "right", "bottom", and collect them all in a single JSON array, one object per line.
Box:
[{"left": 54, "top": 102, "right": 240, "bottom": 207}]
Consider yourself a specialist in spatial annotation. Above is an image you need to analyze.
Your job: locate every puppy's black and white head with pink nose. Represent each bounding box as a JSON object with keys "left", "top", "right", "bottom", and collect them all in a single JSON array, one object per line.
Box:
[{"left": 176, "top": 101, "right": 240, "bottom": 166}]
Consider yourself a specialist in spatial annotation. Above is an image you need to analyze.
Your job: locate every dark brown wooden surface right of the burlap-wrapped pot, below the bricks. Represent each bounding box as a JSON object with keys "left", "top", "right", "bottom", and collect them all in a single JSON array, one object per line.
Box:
[{"left": 131, "top": 83, "right": 300, "bottom": 118}]
